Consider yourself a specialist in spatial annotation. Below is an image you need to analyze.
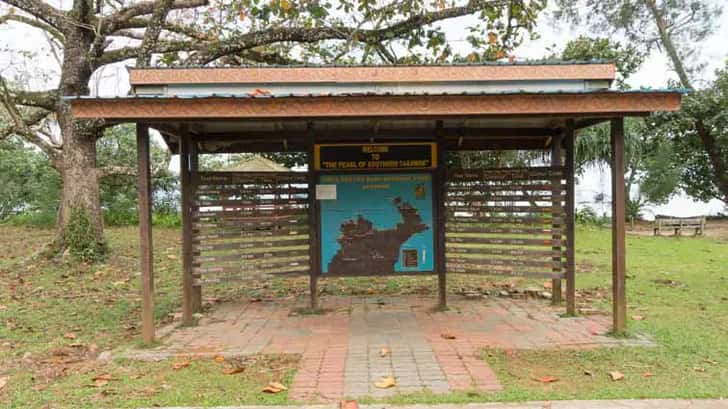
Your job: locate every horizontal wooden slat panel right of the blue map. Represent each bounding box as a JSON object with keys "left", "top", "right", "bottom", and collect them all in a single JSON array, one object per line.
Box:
[{"left": 445, "top": 166, "right": 566, "bottom": 278}]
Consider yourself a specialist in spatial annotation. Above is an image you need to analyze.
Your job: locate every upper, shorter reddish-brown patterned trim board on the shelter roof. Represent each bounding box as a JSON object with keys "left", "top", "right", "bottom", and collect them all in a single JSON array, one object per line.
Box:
[{"left": 129, "top": 63, "right": 616, "bottom": 86}]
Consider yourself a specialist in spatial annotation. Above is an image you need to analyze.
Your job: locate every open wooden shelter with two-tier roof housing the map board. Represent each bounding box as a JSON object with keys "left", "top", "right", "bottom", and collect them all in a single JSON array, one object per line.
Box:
[{"left": 68, "top": 62, "right": 681, "bottom": 341}]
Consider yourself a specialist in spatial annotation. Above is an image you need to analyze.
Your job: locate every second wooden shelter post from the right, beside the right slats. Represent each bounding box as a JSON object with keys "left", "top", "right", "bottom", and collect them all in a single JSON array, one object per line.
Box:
[{"left": 564, "top": 121, "right": 576, "bottom": 315}]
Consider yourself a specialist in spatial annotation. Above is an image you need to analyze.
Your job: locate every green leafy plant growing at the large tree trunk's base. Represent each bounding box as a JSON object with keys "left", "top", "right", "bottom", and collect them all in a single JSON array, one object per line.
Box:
[{"left": 63, "top": 207, "right": 106, "bottom": 262}]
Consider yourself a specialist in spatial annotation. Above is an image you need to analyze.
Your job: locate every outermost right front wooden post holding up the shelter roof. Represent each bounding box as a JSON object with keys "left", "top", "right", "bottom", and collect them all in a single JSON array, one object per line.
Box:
[{"left": 610, "top": 118, "right": 627, "bottom": 333}]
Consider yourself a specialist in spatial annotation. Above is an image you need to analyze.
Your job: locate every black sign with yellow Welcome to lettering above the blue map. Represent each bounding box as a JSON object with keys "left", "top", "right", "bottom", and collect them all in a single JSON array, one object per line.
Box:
[{"left": 314, "top": 142, "right": 437, "bottom": 170}]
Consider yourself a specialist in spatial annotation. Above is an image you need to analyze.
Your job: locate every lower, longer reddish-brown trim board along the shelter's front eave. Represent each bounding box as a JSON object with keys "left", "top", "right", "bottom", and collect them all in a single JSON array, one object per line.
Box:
[{"left": 71, "top": 91, "right": 681, "bottom": 121}]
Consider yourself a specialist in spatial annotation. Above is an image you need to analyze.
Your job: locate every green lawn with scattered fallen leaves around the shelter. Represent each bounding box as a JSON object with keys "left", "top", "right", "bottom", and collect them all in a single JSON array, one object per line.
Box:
[{"left": 0, "top": 226, "right": 728, "bottom": 408}]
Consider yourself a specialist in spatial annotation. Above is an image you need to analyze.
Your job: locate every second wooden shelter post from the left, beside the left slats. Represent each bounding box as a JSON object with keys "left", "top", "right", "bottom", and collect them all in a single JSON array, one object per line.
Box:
[{"left": 179, "top": 125, "right": 193, "bottom": 325}]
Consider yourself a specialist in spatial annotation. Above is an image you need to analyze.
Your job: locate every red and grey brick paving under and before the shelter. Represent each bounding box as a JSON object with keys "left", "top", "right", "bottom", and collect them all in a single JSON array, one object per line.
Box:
[{"left": 127, "top": 296, "right": 652, "bottom": 401}]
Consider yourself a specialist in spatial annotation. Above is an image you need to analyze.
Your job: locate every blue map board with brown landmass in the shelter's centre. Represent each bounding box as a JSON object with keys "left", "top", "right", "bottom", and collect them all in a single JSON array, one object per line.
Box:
[{"left": 319, "top": 173, "right": 434, "bottom": 275}]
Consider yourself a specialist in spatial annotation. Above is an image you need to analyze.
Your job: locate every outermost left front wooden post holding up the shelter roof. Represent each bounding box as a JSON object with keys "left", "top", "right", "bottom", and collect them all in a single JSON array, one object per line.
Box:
[{"left": 136, "top": 124, "right": 154, "bottom": 344}]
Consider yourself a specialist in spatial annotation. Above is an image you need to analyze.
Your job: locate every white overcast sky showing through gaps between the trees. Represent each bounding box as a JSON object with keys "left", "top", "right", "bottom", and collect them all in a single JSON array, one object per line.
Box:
[{"left": 0, "top": 0, "right": 728, "bottom": 217}]
